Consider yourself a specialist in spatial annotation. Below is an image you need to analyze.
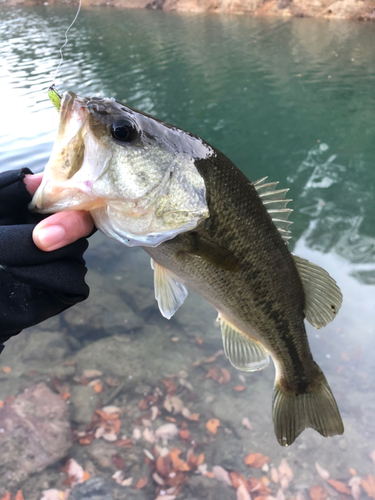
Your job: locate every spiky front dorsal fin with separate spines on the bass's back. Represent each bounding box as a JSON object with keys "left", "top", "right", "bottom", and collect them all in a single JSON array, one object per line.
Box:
[{"left": 253, "top": 177, "right": 293, "bottom": 244}]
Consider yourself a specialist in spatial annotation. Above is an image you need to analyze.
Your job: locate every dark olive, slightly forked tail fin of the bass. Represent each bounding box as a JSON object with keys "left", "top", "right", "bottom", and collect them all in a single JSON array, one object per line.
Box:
[{"left": 273, "top": 367, "right": 344, "bottom": 446}]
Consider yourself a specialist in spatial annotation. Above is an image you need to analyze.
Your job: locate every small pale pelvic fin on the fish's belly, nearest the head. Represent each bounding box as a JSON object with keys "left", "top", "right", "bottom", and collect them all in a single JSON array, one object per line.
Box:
[{"left": 151, "top": 259, "right": 188, "bottom": 319}]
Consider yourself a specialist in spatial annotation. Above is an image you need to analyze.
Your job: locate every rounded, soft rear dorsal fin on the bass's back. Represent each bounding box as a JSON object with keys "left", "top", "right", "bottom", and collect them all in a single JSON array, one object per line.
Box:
[{"left": 293, "top": 255, "right": 342, "bottom": 328}]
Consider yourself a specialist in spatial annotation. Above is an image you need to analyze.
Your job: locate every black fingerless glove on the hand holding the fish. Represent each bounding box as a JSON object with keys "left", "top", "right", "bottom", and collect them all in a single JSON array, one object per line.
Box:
[{"left": 0, "top": 168, "right": 89, "bottom": 352}]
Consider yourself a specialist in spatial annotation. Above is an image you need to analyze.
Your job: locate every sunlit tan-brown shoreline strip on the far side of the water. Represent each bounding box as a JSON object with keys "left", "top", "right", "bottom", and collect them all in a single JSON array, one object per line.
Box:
[{"left": 2, "top": 0, "right": 375, "bottom": 21}]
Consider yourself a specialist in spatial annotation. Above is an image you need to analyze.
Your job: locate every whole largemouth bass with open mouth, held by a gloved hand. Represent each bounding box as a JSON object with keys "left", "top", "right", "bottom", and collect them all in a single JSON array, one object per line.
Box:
[{"left": 30, "top": 91, "right": 344, "bottom": 446}]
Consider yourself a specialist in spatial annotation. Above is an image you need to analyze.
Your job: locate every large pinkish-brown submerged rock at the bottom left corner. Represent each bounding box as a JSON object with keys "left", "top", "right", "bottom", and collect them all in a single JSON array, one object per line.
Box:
[{"left": 0, "top": 383, "right": 71, "bottom": 495}]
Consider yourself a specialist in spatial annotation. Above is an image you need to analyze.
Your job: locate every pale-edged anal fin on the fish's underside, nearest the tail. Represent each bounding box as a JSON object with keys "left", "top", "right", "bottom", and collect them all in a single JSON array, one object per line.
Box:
[{"left": 219, "top": 316, "right": 269, "bottom": 372}]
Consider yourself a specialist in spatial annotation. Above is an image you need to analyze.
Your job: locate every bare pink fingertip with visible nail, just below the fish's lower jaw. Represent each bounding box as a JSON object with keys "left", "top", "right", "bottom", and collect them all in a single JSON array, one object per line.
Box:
[{"left": 33, "top": 210, "right": 94, "bottom": 252}]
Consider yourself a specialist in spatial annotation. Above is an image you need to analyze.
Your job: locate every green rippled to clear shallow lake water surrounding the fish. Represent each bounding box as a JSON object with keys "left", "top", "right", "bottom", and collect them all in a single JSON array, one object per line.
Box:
[{"left": 0, "top": 7, "right": 375, "bottom": 500}]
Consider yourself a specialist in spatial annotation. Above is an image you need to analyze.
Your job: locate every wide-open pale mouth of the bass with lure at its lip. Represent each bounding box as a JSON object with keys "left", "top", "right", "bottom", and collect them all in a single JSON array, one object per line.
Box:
[{"left": 29, "top": 92, "right": 104, "bottom": 213}]
